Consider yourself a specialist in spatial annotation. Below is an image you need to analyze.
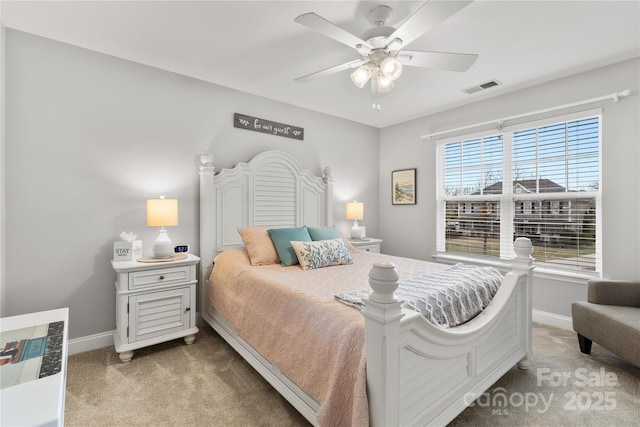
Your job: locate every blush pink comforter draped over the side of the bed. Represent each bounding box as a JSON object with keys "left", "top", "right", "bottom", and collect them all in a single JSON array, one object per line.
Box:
[{"left": 208, "top": 250, "right": 443, "bottom": 426}]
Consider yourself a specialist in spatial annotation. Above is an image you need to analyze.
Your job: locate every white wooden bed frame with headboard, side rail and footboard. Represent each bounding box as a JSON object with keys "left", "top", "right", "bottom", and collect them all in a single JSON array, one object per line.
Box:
[{"left": 200, "top": 151, "right": 533, "bottom": 426}]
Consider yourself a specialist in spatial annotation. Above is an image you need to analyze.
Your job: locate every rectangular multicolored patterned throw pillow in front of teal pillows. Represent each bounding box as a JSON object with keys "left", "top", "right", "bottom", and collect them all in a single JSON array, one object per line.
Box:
[{"left": 291, "top": 239, "right": 353, "bottom": 270}]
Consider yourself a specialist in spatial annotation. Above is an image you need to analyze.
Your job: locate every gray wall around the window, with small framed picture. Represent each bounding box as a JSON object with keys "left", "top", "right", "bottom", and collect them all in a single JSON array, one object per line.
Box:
[{"left": 380, "top": 59, "right": 640, "bottom": 316}]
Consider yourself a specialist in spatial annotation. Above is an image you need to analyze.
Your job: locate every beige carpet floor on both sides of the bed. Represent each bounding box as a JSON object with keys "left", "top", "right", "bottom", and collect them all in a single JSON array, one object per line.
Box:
[{"left": 65, "top": 325, "right": 640, "bottom": 427}]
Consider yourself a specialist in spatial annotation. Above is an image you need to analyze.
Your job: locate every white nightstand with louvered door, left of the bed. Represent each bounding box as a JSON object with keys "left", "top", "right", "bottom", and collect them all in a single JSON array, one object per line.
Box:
[{"left": 111, "top": 254, "right": 200, "bottom": 362}]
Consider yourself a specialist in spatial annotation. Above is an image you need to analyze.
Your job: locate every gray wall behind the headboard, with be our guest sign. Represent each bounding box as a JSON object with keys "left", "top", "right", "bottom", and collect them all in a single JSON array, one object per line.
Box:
[{"left": 4, "top": 29, "right": 379, "bottom": 338}]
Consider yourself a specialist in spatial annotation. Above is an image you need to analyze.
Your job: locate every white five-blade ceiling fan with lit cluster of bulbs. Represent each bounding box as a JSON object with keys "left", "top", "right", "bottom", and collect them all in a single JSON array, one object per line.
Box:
[{"left": 295, "top": 0, "right": 478, "bottom": 99}]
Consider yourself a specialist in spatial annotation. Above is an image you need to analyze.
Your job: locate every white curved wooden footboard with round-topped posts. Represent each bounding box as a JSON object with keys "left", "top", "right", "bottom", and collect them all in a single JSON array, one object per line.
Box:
[{"left": 363, "top": 238, "right": 533, "bottom": 426}]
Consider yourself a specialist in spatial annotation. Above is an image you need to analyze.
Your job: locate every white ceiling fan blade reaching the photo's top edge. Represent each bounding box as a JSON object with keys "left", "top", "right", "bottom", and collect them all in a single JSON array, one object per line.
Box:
[{"left": 385, "top": 0, "right": 473, "bottom": 49}]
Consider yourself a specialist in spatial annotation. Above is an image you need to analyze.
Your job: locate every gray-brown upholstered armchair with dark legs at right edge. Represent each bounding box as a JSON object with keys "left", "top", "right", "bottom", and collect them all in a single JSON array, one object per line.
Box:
[{"left": 571, "top": 280, "right": 640, "bottom": 366}]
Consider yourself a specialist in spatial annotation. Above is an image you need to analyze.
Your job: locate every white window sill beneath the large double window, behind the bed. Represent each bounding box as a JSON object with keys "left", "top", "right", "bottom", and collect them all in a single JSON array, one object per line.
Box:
[{"left": 432, "top": 252, "right": 601, "bottom": 285}]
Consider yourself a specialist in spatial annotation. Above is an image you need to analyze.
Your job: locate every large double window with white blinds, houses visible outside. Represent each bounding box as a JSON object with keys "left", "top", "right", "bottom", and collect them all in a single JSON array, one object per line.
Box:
[{"left": 437, "top": 111, "right": 601, "bottom": 272}]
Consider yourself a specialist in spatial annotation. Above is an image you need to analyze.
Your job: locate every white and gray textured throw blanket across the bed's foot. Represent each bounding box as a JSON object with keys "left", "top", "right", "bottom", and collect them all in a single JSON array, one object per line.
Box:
[{"left": 335, "top": 264, "right": 502, "bottom": 328}]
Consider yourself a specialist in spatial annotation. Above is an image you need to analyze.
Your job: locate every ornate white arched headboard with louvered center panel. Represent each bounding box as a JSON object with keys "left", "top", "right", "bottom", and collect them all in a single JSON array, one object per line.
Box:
[{"left": 199, "top": 150, "right": 333, "bottom": 308}]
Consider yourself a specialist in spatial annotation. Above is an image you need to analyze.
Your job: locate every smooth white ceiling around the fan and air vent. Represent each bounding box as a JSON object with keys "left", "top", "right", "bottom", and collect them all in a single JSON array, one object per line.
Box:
[{"left": 0, "top": 0, "right": 640, "bottom": 128}]
